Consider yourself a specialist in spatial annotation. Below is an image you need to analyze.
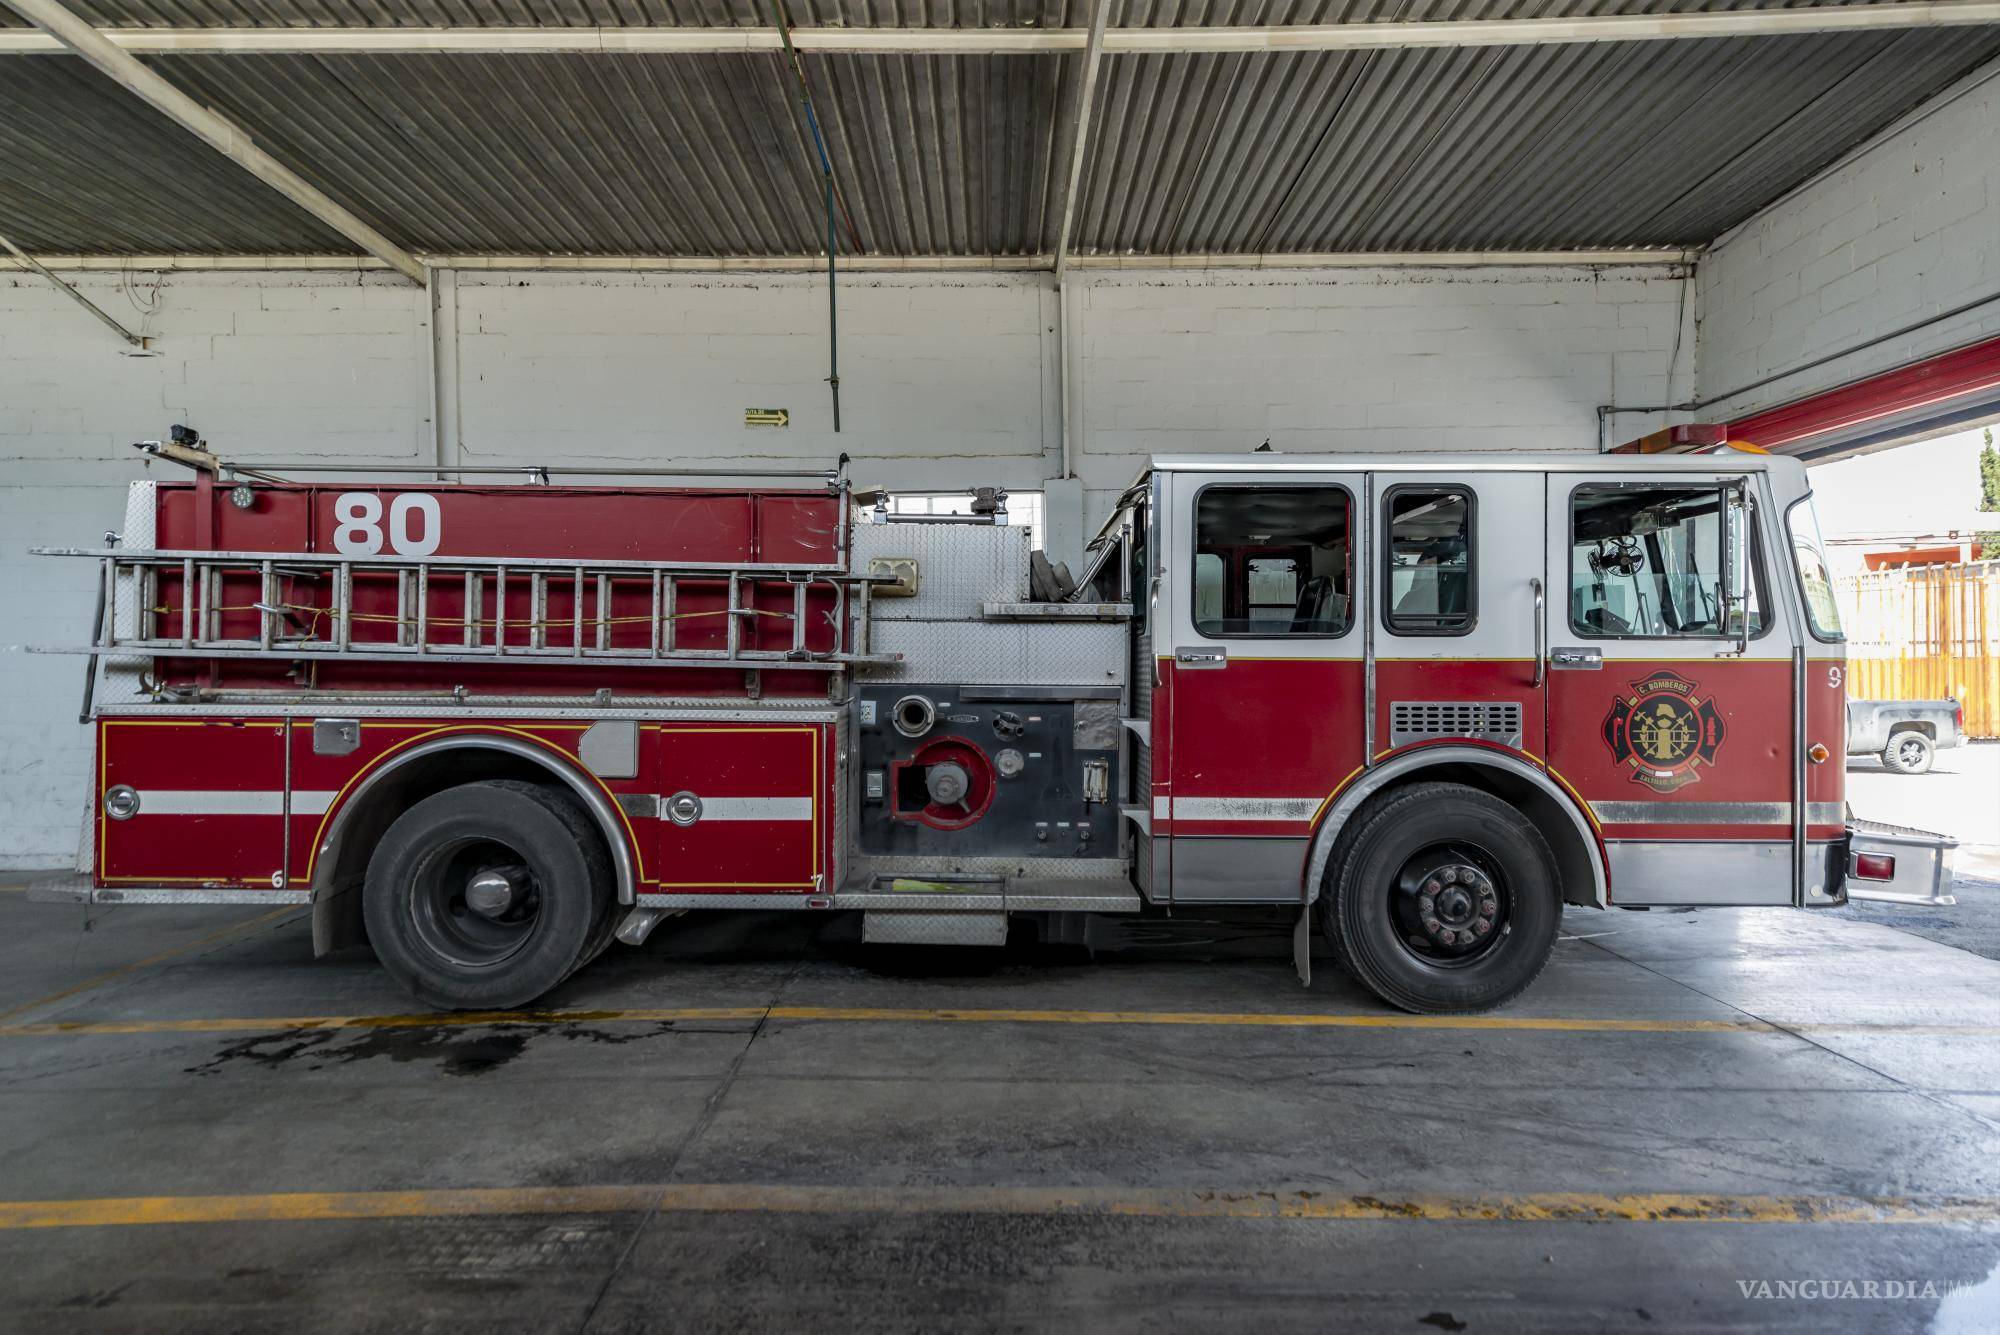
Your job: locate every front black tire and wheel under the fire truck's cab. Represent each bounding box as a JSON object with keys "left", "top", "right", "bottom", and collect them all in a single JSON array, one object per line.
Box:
[{"left": 1320, "top": 783, "right": 1562, "bottom": 1015}]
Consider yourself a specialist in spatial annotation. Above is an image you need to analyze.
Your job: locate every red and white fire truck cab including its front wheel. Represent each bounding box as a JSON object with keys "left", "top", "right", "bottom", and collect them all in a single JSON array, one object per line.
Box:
[{"left": 1092, "top": 450, "right": 1936, "bottom": 1009}]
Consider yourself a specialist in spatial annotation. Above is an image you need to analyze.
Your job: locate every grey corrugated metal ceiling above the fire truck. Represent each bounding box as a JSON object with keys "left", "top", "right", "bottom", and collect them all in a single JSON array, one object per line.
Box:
[{"left": 0, "top": 0, "right": 2000, "bottom": 256}]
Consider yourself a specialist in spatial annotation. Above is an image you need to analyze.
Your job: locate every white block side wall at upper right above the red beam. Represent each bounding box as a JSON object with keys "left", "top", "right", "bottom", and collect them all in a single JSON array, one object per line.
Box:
[{"left": 1696, "top": 64, "right": 2000, "bottom": 413}]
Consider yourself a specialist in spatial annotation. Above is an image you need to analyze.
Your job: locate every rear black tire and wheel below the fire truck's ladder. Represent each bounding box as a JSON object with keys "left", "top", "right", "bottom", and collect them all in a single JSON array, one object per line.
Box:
[{"left": 362, "top": 779, "right": 612, "bottom": 1009}]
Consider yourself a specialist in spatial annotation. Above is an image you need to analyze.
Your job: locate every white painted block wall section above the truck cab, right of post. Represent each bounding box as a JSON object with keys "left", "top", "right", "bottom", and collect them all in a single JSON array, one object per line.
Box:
[{"left": 1078, "top": 268, "right": 1694, "bottom": 524}]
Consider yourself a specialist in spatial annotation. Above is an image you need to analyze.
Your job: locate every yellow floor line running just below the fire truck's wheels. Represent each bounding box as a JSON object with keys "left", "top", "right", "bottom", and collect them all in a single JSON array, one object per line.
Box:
[{"left": 11, "top": 1005, "right": 2000, "bottom": 1037}]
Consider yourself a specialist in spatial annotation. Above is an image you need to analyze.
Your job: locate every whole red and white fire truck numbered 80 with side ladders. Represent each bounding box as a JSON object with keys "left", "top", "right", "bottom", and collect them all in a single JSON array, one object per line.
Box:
[{"left": 31, "top": 428, "right": 1950, "bottom": 1011}]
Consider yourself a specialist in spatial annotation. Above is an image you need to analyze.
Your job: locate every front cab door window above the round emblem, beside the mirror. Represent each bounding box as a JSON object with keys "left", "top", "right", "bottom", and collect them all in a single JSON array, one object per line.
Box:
[{"left": 1570, "top": 486, "right": 1764, "bottom": 640}]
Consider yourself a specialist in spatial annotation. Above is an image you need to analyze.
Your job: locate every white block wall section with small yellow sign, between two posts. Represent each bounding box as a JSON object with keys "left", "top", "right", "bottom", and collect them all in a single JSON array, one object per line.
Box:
[{"left": 458, "top": 274, "right": 1054, "bottom": 481}]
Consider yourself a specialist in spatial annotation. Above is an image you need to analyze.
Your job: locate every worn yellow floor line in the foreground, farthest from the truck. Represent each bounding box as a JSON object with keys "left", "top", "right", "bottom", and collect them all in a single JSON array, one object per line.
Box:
[{"left": 0, "top": 1183, "right": 2000, "bottom": 1229}]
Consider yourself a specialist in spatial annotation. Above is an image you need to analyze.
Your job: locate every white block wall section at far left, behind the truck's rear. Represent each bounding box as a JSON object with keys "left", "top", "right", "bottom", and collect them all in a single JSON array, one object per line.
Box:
[{"left": 0, "top": 274, "right": 430, "bottom": 867}]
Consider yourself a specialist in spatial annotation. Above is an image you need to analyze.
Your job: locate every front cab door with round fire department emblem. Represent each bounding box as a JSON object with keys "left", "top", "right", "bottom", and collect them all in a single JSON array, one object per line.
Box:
[{"left": 1546, "top": 472, "right": 1794, "bottom": 903}]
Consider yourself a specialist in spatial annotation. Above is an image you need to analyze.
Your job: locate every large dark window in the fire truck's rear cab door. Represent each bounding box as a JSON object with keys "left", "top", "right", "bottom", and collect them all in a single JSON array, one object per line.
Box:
[{"left": 1194, "top": 486, "right": 1354, "bottom": 638}]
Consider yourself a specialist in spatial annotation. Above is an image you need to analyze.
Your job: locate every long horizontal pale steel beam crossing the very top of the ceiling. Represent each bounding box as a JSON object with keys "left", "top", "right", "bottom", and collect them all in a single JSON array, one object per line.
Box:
[{"left": 0, "top": 0, "right": 2000, "bottom": 56}]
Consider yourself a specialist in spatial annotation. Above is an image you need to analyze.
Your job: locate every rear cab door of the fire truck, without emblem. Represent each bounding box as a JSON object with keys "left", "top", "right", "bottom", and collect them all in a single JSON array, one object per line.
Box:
[{"left": 1150, "top": 470, "right": 1368, "bottom": 903}]
